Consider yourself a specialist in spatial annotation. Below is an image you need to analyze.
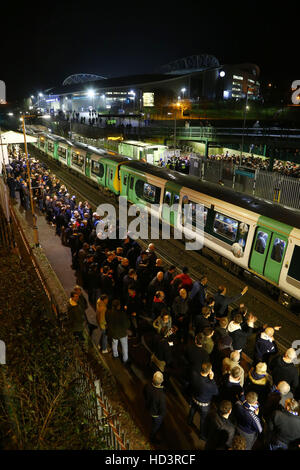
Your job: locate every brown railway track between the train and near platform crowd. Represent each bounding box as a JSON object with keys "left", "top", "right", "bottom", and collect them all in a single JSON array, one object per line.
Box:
[{"left": 31, "top": 148, "right": 300, "bottom": 358}]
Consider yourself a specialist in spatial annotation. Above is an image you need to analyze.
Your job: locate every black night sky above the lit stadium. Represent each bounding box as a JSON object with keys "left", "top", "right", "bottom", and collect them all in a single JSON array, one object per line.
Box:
[{"left": 0, "top": 0, "right": 300, "bottom": 101}]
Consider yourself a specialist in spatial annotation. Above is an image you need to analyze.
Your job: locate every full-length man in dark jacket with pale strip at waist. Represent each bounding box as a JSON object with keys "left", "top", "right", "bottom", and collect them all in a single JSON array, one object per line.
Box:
[{"left": 188, "top": 362, "right": 219, "bottom": 440}]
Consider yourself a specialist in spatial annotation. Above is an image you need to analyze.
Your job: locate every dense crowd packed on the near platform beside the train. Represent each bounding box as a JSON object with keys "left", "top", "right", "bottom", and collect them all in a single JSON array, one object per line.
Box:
[{"left": 7, "top": 148, "right": 300, "bottom": 450}]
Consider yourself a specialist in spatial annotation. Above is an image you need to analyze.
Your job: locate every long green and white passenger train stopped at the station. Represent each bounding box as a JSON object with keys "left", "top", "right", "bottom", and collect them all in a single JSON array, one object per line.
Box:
[{"left": 26, "top": 132, "right": 300, "bottom": 314}]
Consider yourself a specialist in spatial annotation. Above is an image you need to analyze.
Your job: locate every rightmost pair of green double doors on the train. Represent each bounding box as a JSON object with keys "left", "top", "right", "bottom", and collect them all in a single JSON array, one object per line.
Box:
[{"left": 249, "top": 227, "right": 288, "bottom": 283}]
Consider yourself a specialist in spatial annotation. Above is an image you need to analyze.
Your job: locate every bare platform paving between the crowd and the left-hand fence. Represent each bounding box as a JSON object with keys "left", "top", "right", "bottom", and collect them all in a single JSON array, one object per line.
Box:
[{"left": 11, "top": 192, "right": 204, "bottom": 450}]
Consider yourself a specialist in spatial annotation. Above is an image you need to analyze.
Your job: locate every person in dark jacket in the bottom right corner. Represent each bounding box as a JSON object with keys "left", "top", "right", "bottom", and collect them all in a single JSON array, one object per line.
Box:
[{"left": 268, "top": 398, "right": 300, "bottom": 450}]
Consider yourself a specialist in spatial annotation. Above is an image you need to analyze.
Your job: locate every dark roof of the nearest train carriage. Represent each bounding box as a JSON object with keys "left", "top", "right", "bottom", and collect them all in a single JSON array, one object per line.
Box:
[{"left": 122, "top": 160, "right": 300, "bottom": 229}]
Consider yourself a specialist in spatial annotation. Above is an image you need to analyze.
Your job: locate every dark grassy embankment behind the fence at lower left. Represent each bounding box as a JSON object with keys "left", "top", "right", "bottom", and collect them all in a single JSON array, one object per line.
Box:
[{"left": 0, "top": 253, "right": 104, "bottom": 450}]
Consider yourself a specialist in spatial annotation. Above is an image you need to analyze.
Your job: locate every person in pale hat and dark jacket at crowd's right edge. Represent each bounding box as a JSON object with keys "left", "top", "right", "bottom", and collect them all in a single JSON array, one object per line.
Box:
[{"left": 270, "top": 348, "right": 299, "bottom": 393}]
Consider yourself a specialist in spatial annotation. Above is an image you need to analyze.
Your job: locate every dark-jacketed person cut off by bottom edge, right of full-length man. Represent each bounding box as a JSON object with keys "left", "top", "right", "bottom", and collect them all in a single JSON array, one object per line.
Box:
[{"left": 205, "top": 400, "right": 235, "bottom": 450}]
